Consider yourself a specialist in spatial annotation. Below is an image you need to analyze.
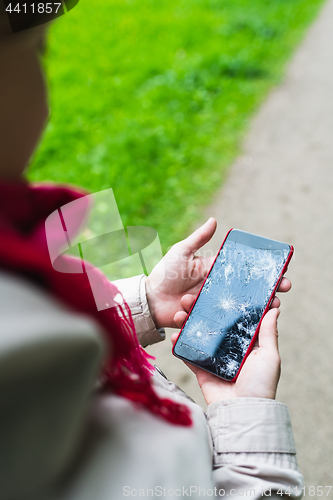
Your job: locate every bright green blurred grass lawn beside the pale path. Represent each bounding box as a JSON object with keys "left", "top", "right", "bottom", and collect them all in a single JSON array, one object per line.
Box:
[{"left": 29, "top": 0, "right": 323, "bottom": 250}]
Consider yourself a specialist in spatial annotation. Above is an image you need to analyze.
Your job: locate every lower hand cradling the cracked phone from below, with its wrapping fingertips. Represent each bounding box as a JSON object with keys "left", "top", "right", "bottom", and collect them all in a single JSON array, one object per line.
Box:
[{"left": 171, "top": 306, "right": 282, "bottom": 404}]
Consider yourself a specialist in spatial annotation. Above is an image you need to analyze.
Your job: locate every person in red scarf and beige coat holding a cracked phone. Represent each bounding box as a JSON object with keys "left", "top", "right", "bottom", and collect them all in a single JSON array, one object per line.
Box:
[{"left": 0, "top": 3, "right": 302, "bottom": 500}]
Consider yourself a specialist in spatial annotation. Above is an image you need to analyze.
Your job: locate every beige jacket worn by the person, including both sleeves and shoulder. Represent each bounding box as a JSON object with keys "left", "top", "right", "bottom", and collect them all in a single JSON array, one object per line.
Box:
[{"left": 0, "top": 273, "right": 303, "bottom": 500}]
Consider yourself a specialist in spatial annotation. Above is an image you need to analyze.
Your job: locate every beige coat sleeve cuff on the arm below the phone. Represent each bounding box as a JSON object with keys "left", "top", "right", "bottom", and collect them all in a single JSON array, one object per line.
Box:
[{"left": 207, "top": 398, "right": 303, "bottom": 499}]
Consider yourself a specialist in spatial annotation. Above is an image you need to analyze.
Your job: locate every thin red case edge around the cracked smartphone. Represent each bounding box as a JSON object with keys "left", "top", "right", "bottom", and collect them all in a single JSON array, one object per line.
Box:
[{"left": 172, "top": 228, "right": 294, "bottom": 382}]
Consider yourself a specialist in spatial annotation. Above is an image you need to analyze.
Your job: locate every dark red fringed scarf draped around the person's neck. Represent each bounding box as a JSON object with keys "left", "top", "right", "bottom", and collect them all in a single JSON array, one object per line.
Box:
[{"left": 0, "top": 182, "right": 191, "bottom": 426}]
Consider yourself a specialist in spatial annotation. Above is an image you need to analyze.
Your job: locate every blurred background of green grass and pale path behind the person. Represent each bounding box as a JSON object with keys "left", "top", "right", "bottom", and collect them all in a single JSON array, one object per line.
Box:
[{"left": 28, "top": 0, "right": 333, "bottom": 497}]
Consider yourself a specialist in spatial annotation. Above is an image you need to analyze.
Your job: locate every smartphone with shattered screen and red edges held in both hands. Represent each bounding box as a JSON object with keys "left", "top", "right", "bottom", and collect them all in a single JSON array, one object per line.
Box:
[{"left": 173, "top": 229, "right": 294, "bottom": 381}]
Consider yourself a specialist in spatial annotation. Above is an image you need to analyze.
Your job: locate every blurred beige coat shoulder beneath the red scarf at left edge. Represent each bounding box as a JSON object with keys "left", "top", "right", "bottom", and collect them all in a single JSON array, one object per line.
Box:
[{"left": 0, "top": 272, "right": 103, "bottom": 498}]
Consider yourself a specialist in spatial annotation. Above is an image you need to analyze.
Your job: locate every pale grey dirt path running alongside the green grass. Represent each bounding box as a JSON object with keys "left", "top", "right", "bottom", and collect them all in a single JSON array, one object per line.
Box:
[{"left": 147, "top": 0, "right": 333, "bottom": 488}]
